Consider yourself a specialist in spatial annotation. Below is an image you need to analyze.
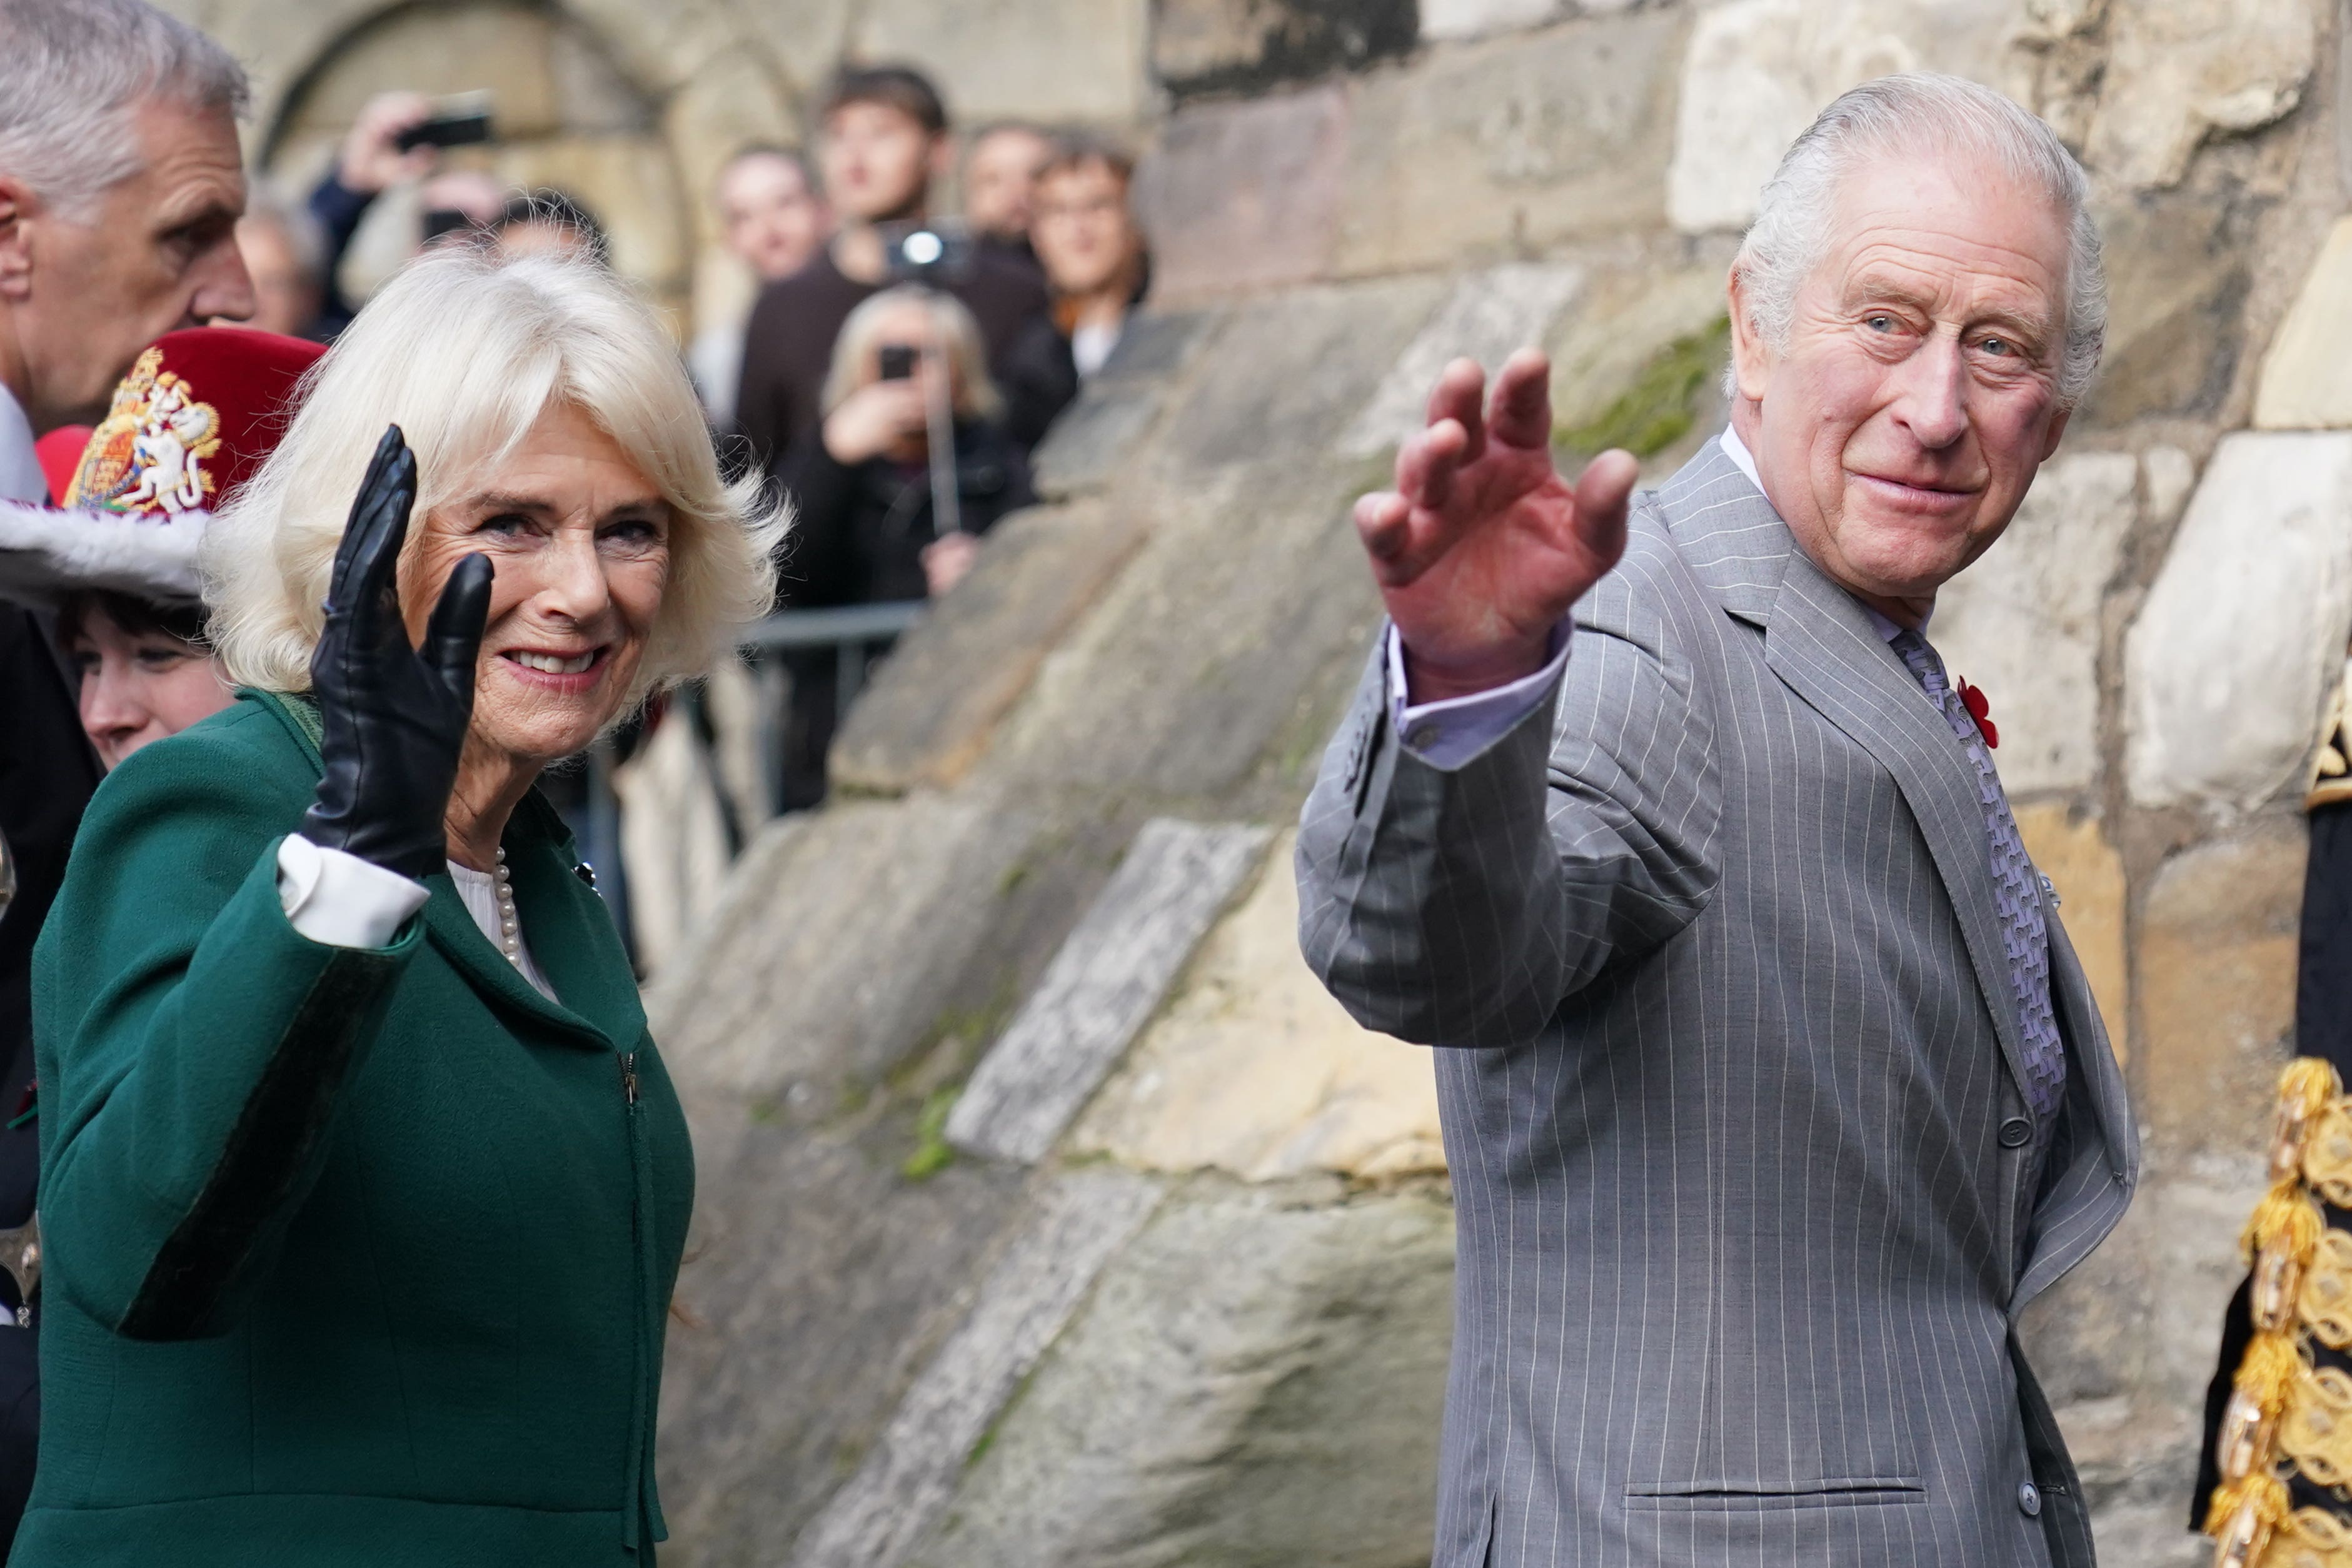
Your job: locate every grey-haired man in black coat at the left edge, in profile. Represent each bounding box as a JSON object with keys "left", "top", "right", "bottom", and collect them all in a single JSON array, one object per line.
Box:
[{"left": 0, "top": 0, "right": 254, "bottom": 1554}]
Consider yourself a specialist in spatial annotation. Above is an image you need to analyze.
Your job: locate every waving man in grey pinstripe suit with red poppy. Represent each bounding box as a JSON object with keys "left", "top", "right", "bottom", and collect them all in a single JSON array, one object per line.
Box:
[{"left": 1299, "top": 75, "right": 2138, "bottom": 1568}]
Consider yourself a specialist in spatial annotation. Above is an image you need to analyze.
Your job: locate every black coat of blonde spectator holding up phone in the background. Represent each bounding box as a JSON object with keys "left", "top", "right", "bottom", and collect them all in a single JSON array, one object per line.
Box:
[{"left": 774, "top": 423, "right": 1037, "bottom": 811}]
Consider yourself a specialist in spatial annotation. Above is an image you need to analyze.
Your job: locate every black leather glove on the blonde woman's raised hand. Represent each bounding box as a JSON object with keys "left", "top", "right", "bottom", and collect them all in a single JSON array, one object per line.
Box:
[{"left": 301, "top": 426, "right": 491, "bottom": 877}]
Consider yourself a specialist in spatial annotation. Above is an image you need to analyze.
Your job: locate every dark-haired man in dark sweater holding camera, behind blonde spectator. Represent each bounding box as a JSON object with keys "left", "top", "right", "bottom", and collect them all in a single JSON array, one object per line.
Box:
[{"left": 734, "top": 66, "right": 1058, "bottom": 468}]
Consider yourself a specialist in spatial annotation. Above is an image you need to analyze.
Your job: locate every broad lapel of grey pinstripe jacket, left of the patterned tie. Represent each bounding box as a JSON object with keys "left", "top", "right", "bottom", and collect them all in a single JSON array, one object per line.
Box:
[{"left": 1658, "top": 442, "right": 2025, "bottom": 1091}]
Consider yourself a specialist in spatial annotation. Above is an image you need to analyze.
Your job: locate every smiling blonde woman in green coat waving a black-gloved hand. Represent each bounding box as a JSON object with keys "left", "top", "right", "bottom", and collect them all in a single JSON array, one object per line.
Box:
[{"left": 12, "top": 249, "right": 781, "bottom": 1568}]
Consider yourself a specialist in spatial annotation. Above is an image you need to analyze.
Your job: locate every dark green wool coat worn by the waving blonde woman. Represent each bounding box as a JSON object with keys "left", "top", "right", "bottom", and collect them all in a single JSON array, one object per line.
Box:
[{"left": 9, "top": 691, "right": 694, "bottom": 1568}]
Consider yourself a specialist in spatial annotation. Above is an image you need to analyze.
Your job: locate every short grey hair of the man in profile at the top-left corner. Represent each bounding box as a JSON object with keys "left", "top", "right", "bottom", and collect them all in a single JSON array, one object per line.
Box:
[{"left": 0, "top": 0, "right": 249, "bottom": 221}]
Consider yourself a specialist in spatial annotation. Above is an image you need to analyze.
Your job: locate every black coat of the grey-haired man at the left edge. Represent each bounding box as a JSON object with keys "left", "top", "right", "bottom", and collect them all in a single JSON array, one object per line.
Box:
[{"left": 0, "top": 602, "right": 99, "bottom": 1556}]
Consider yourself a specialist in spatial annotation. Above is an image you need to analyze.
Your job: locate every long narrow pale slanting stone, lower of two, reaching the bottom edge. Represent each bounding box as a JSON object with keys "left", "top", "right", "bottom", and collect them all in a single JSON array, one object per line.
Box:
[{"left": 790, "top": 1171, "right": 1160, "bottom": 1568}]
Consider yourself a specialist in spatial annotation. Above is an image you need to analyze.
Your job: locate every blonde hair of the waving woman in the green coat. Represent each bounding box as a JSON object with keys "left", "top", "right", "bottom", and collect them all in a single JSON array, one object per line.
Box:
[{"left": 203, "top": 244, "right": 788, "bottom": 712}]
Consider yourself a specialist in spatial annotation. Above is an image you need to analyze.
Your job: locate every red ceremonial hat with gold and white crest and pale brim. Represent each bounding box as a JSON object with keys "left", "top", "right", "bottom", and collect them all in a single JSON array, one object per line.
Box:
[{"left": 0, "top": 327, "right": 327, "bottom": 604}]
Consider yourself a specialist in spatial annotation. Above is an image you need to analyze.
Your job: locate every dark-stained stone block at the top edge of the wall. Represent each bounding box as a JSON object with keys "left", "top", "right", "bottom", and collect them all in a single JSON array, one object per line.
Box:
[{"left": 1152, "top": 0, "right": 1414, "bottom": 99}]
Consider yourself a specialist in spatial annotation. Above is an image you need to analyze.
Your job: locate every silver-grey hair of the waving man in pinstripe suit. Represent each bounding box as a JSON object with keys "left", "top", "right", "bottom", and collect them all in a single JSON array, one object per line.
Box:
[{"left": 1724, "top": 71, "right": 2108, "bottom": 407}]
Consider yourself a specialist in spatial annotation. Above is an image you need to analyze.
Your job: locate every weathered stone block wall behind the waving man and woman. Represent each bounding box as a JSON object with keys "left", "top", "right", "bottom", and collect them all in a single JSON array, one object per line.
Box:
[{"left": 166, "top": 0, "right": 2352, "bottom": 1568}]
